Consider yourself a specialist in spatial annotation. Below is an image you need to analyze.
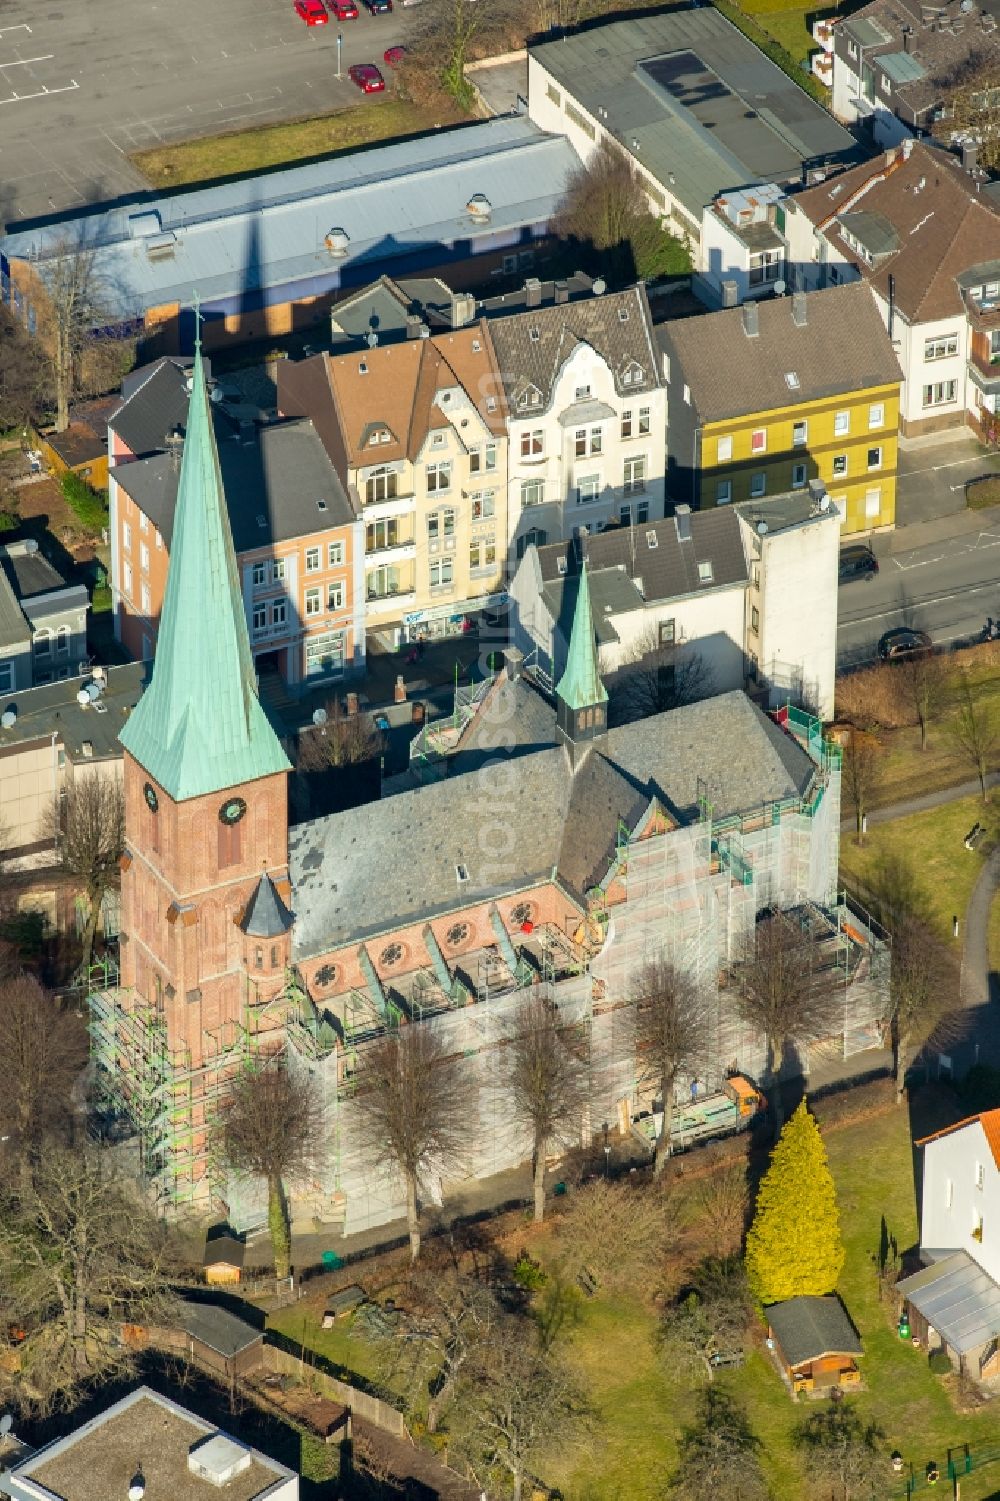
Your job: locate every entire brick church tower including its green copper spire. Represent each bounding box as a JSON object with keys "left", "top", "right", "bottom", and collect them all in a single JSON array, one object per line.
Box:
[{"left": 110, "top": 331, "right": 293, "bottom": 1180}]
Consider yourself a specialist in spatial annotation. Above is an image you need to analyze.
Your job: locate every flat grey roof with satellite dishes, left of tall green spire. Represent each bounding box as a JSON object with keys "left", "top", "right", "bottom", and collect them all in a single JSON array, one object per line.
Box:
[{"left": 0, "top": 663, "right": 147, "bottom": 761}]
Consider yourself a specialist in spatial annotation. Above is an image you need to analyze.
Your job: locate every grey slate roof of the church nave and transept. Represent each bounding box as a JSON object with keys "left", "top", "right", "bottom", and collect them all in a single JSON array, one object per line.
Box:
[{"left": 288, "top": 678, "right": 815, "bottom": 959}]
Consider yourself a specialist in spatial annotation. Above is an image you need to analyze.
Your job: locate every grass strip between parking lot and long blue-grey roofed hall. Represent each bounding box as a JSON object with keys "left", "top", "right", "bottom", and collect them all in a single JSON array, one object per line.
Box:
[{"left": 131, "top": 93, "right": 459, "bottom": 188}]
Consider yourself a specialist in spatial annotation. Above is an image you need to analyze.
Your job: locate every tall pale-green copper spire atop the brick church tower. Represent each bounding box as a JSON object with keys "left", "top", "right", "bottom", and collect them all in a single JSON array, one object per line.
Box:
[{"left": 120, "top": 322, "right": 290, "bottom": 802}]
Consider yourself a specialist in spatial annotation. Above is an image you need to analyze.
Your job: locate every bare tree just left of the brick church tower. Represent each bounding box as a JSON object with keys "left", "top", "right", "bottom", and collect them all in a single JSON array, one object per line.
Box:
[{"left": 50, "top": 772, "right": 125, "bottom": 976}]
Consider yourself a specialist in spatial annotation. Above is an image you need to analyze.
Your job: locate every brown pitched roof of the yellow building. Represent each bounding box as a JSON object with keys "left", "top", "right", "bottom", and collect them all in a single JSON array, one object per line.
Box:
[{"left": 656, "top": 282, "right": 902, "bottom": 422}]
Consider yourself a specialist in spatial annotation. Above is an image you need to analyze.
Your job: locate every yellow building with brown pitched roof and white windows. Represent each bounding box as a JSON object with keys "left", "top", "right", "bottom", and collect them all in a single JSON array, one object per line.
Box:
[{"left": 656, "top": 285, "right": 901, "bottom": 536}]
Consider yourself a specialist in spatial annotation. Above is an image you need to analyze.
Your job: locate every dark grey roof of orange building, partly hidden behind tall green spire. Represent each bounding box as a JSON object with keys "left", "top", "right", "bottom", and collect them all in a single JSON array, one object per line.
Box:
[{"left": 114, "top": 417, "right": 354, "bottom": 552}]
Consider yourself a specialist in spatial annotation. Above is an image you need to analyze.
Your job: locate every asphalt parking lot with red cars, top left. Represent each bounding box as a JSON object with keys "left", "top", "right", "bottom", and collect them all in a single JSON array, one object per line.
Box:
[{"left": 0, "top": 0, "right": 413, "bottom": 224}]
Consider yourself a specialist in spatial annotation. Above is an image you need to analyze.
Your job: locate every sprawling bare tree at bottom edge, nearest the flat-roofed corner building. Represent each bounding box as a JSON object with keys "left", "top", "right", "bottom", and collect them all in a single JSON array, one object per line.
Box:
[{"left": 455, "top": 1318, "right": 580, "bottom": 1501}]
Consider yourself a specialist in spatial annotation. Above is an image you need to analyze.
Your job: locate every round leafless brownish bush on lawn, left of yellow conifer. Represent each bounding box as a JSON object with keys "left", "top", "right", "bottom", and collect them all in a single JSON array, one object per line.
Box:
[{"left": 556, "top": 1178, "right": 671, "bottom": 1291}]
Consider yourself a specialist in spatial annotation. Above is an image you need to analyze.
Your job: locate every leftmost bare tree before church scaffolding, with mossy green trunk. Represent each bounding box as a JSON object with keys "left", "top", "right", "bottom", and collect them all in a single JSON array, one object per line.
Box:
[{"left": 216, "top": 1058, "right": 323, "bottom": 1277}]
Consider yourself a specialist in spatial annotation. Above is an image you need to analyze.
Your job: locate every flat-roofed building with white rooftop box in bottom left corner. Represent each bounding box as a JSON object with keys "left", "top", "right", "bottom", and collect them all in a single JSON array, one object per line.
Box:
[{"left": 0, "top": 1387, "right": 299, "bottom": 1501}]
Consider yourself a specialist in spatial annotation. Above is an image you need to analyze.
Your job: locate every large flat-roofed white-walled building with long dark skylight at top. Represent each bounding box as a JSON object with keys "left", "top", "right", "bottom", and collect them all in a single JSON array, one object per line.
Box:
[{"left": 529, "top": 6, "right": 863, "bottom": 255}]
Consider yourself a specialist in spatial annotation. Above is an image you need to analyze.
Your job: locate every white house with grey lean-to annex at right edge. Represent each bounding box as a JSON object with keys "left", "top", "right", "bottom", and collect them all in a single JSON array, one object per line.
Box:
[{"left": 896, "top": 1111, "right": 1000, "bottom": 1381}]
